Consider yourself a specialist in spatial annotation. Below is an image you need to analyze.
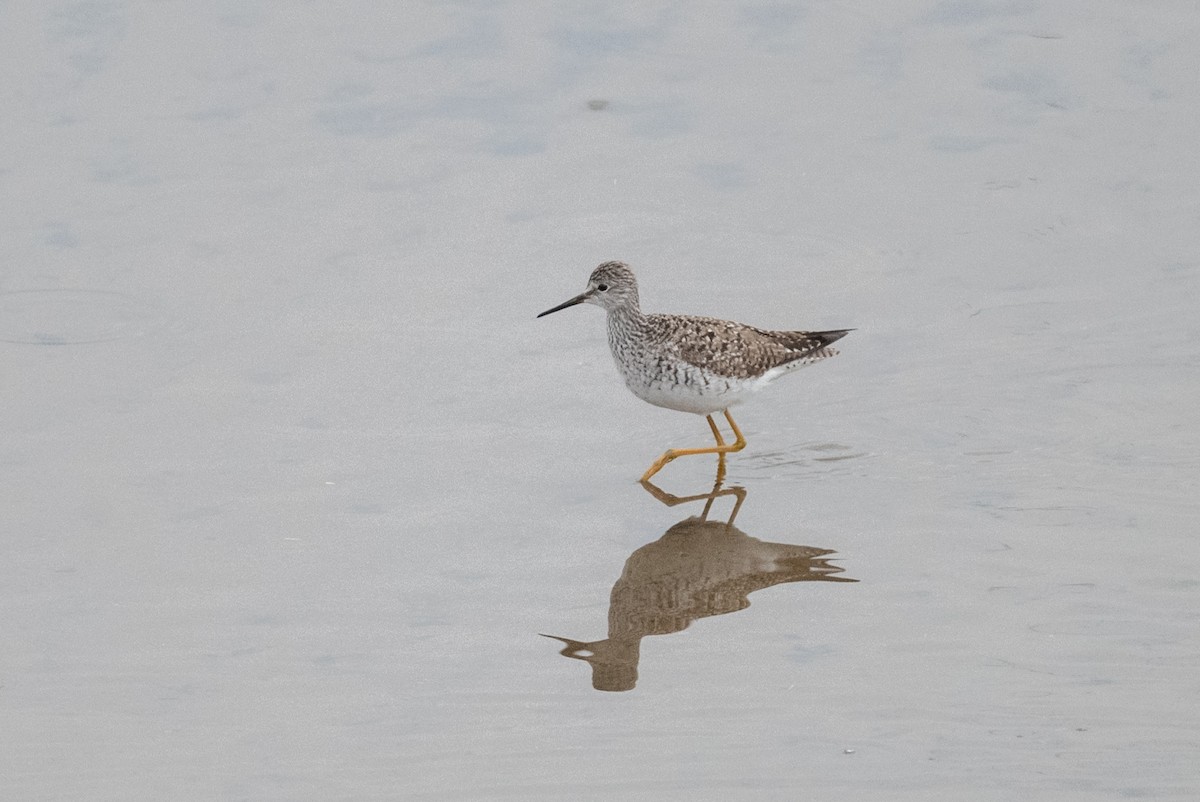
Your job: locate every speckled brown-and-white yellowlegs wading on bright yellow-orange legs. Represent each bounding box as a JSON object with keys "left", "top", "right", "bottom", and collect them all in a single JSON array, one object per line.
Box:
[{"left": 538, "top": 262, "right": 853, "bottom": 481}]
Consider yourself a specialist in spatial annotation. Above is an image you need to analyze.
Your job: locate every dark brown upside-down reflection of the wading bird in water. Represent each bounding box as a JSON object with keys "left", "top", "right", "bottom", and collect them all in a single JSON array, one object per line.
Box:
[{"left": 546, "top": 472, "right": 858, "bottom": 690}]
